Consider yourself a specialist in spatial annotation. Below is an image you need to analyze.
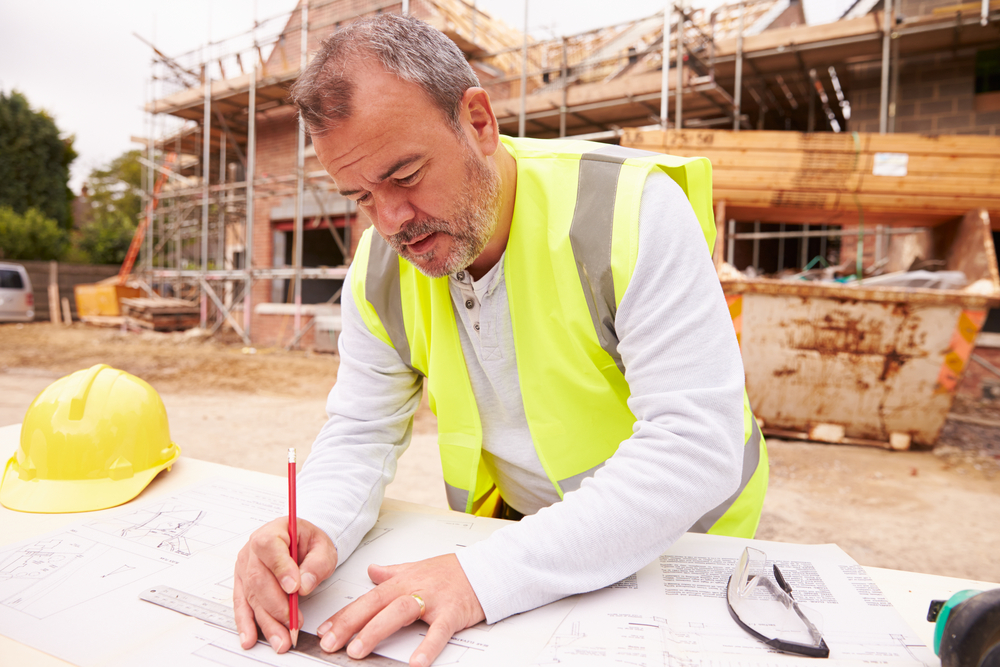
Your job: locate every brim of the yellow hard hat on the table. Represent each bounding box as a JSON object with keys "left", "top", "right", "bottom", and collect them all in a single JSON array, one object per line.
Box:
[{"left": 0, "top": 443, "right": 181, "bottom": 514}]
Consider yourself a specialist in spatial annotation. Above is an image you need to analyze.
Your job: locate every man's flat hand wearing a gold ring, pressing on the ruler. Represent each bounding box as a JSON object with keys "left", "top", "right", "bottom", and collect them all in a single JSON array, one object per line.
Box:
[{"left": 318, "top": 554, "right": 486, "bottom": 667}]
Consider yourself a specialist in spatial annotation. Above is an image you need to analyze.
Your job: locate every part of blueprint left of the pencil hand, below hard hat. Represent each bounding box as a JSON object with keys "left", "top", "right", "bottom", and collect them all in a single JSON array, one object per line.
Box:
[{"left": 0, "top": 481, "right": 286, "bottom": 665}]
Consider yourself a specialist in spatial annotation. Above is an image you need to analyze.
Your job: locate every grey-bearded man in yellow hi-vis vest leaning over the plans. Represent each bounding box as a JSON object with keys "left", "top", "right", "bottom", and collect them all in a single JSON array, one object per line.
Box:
[{"left": 234, "top": 15, "right": 767, "bottom": 667}]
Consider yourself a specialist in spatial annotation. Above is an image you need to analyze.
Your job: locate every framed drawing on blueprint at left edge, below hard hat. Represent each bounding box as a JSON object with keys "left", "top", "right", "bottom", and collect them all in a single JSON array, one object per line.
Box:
[{"left": 0, "top": 531, "right": 169, "bottom": 618}]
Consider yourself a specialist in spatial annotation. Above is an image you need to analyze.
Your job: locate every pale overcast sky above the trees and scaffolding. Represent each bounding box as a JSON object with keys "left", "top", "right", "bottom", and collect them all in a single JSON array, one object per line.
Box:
[{"left": 0, "top": 0, "right": 736, "bottom": 191}]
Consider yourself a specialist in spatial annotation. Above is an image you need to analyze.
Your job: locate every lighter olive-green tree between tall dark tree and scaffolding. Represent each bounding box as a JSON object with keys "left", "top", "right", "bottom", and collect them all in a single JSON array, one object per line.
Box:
[{"left": 79, "top": 150, "right": 143, "bottom": 264}]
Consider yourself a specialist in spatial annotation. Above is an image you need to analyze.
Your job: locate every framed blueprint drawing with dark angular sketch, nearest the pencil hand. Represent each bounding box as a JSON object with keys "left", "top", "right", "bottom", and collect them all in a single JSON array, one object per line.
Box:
[{"left": 87, "top": 500, "right": 257, "bottom": 558}]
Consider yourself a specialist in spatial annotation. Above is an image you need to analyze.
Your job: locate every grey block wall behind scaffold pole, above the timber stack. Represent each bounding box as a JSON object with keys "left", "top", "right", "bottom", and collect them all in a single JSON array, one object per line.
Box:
[{"left": 847, "top": 49, "right": 1000, "bottom": 136}]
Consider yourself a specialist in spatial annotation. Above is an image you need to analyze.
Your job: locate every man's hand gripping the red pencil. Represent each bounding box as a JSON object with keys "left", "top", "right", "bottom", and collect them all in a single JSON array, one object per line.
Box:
[{"left": 233, "top": 517, "right": 337, "bottom": 653}]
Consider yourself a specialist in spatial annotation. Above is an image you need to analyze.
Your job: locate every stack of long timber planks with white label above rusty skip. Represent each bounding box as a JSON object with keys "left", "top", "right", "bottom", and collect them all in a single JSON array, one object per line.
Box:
[{"left": 621, "top": 130, "right": 1000, "bottom": 230}]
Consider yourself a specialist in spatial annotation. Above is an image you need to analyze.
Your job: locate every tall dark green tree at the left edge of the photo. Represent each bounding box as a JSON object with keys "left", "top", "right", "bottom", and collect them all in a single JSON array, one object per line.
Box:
[{"left": 0, "top": 91, "right": 77, "bottom": 229}]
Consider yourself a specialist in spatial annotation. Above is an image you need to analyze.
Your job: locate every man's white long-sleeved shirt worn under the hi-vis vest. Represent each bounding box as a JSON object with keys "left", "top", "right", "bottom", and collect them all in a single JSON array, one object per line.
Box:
[{"left": 298, "top": 172, "right": 744, "bottom": 623}]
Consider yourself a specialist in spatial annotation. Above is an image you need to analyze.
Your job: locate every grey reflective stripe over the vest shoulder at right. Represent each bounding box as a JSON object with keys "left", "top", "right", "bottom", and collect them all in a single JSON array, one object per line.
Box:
[{"left": 572, "top": 146, "right": 658, "bottom": 378}]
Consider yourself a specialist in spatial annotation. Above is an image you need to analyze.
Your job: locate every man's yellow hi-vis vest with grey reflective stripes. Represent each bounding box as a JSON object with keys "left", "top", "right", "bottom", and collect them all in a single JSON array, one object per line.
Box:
[{"left": 351, "top": 137, "right": 768, "bottom": 537}]
